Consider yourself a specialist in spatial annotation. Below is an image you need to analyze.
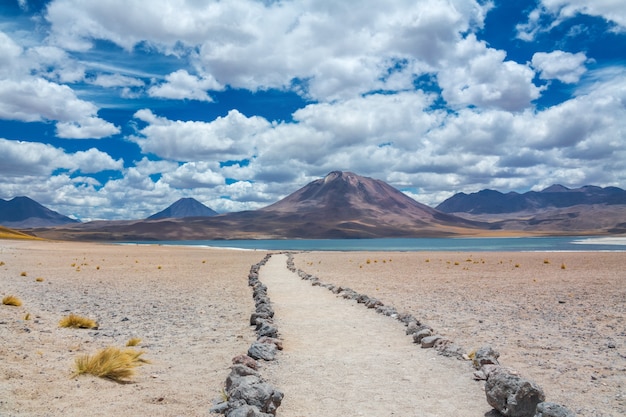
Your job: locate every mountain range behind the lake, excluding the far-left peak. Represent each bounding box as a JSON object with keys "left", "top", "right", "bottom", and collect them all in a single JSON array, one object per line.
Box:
[{"left": 0, "top": 171, "right": 626, "bottom": 241}]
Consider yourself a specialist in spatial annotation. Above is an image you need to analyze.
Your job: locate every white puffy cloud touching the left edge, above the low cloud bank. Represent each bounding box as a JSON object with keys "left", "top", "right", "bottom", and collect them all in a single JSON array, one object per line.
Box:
[{"left": 0, "top": 78, "right": 120, "bottom": 139}]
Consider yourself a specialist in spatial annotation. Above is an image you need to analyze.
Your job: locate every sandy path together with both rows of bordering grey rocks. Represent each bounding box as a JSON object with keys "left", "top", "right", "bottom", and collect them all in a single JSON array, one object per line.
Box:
[{"left": 211, "top": 253, "right": 574, "bottom": 417}]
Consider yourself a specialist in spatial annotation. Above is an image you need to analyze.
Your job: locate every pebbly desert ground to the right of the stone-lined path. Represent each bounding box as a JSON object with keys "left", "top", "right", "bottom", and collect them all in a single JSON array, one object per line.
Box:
[{"left": 295, "top": 252, "right": 626, "bottom": 417}]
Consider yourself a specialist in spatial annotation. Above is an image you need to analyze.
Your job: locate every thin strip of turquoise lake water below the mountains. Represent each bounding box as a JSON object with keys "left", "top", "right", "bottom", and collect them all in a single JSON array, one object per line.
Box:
[{"left": 124, "top": 236, "right": 626, "bottom": 252}]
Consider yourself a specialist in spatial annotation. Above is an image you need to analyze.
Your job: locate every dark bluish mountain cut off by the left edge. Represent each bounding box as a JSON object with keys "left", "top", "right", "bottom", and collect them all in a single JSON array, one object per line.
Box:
[{"left": 0, "top": 197, "right": 78, "bottom": 229}]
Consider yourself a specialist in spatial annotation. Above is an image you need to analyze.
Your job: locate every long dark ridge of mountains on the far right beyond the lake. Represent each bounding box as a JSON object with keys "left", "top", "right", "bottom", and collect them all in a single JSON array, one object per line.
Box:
[{"left": 437, "top": 184, "right": 626, "bottom": 215}]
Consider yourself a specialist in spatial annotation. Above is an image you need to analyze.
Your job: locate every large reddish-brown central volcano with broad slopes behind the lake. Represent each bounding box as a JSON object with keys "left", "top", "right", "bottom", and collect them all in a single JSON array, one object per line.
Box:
[{"left": 26, "top": 171, "right": 490, "bottom": 241}]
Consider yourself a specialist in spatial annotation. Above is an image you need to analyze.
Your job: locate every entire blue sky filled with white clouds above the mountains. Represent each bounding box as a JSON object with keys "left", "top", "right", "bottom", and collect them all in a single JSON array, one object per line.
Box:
[{"left": 0, "top": 0, "right": 626, "bottom": 220}]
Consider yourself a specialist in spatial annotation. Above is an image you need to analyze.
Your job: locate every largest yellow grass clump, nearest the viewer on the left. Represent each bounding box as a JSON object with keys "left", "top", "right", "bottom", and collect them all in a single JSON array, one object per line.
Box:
[{"left": 73, "top": 347, "right": 150, "bottom": 383}]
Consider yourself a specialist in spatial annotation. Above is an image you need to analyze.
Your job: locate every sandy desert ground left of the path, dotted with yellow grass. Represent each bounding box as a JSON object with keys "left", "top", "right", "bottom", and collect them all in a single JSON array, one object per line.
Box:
[{"left": 0, "top": 240, "right": 265, "bottom": 417}]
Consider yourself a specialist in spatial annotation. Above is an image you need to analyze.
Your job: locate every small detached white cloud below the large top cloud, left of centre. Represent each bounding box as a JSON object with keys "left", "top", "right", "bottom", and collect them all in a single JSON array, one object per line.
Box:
[{"left": 148, "top": 70, "right": 223, "bottom": 102}]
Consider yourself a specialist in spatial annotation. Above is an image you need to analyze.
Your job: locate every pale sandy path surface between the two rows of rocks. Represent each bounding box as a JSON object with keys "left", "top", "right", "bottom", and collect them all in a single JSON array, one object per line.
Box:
[{"left": 259, "top": 255, "right": 491, "bottom": 417}]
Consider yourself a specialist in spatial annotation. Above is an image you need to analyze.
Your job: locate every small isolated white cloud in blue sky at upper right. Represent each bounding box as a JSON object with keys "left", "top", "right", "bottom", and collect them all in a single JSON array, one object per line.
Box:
[{"left": 532, "top": 51, "right": 587, "bottom": 84}]
